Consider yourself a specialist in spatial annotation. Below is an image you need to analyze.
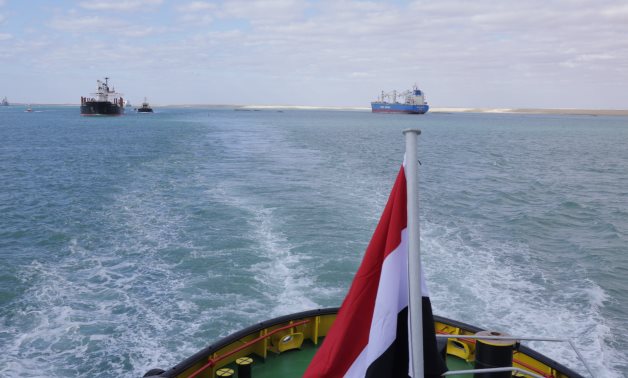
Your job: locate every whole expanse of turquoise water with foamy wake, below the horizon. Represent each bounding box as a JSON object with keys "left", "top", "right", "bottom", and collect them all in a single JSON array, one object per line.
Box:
[{"left": 0, "top": 107, "right": 628, "bottom": 377}]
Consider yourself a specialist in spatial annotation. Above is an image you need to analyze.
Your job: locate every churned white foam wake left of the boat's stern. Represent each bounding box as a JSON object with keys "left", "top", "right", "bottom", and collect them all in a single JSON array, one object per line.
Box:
[{"left": 0, "top": 157, "right": 245, "bottom": 377}]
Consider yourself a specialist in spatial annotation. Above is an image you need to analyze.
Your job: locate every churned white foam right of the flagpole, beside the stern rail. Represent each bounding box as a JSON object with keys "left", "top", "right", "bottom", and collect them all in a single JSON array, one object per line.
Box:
[{"left": 422, "top": 222, "right": 622, "bottom": 377}]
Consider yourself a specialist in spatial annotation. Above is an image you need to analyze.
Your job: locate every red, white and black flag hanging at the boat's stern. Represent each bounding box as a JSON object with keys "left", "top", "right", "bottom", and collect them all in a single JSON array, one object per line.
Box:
[{"left": 304, "top": 166, "right": 447, "bottom": 378}]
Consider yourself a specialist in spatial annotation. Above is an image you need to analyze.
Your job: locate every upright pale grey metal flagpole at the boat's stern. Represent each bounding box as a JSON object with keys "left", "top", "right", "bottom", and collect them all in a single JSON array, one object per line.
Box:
[{"left": 403, "top": 129, "right": 424, "bottom": 378}]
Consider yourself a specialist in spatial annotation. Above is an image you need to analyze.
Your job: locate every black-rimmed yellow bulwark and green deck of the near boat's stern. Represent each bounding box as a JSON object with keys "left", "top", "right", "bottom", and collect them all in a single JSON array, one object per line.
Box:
[{"left": 144, "top": 308, "right": 584, "bottom": 378}]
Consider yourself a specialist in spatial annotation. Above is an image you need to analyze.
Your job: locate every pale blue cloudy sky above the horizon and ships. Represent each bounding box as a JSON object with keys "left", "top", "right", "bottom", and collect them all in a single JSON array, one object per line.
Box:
[{"left": 0, "top": 0, "right": 628, "bottom": 109}]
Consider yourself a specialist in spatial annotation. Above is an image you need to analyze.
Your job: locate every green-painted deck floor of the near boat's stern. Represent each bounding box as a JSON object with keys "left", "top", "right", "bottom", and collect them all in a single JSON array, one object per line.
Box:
[{"left": 220, "top": 341, "right": 473, "bottom": 378}]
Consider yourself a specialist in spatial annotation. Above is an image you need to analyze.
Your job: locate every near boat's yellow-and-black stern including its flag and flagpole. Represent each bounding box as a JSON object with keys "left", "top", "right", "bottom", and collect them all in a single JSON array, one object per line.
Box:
[{"left": 144, "top": 130, "right": 593, "bottom": 378}]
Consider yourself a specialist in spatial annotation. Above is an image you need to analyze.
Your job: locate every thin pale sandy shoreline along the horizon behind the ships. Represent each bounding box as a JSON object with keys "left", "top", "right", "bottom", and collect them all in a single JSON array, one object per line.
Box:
[{"left": 4, "top": 103, "right": 628, "bottom": 116}]
